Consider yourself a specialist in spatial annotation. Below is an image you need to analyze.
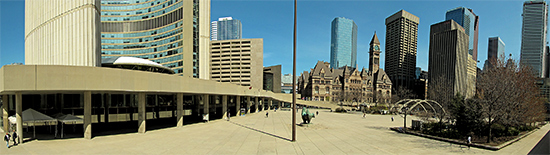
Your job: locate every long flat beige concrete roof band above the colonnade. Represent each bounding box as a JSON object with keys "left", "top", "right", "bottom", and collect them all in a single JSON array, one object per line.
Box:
[{"left": 0, "top": 65, "right": 336, "bottom": 108}]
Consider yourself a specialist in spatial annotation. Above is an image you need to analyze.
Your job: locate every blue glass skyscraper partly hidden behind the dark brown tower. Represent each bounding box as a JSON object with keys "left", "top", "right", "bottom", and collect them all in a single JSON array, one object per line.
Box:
[{"left": 445, "top": 7, "right": 479, "bottom": 61}]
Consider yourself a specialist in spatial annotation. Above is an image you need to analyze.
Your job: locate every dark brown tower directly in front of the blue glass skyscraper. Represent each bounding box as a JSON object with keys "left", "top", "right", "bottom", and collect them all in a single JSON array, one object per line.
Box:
[{"left": 428, "top": 20, "right": 471, "bottom": 98}]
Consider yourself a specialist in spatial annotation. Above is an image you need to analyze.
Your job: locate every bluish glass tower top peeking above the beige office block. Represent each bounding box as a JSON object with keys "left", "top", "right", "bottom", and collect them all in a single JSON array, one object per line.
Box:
[{"left": 211, "top": 17, "right": 243, "bottom": 40}]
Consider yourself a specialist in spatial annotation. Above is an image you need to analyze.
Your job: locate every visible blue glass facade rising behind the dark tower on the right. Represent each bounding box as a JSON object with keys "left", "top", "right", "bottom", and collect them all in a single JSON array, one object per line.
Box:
[{"left": 445, "top": 7, "right": 476, "bottom": 55}]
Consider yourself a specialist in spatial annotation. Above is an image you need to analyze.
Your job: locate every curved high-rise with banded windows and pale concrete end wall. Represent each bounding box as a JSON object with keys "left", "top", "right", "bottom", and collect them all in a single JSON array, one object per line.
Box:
[{"left": 101, "top": 0, "right": 210, "bottom": 79}]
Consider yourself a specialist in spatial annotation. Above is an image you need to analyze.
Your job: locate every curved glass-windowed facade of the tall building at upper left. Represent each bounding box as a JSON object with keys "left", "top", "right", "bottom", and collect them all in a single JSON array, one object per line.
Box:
[{"left": 101, "top": 0, "right": 199, "bottom": 77}]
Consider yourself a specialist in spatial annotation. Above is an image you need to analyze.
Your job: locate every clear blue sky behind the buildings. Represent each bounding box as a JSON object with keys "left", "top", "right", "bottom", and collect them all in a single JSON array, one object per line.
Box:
[{"left": 0, "top": 0, "right": 544, "bottom": 75}]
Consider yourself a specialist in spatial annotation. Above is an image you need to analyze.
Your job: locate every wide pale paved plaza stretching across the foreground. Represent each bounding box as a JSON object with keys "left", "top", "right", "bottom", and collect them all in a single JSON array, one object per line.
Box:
[{"left": 0, "top": 109, "right": 550, "bottom": 155}]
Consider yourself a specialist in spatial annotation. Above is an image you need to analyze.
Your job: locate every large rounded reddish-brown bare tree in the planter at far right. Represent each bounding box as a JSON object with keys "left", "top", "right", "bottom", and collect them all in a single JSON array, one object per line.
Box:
[{"left": 477, "top": 57, "right": 544, "bottom": 143}]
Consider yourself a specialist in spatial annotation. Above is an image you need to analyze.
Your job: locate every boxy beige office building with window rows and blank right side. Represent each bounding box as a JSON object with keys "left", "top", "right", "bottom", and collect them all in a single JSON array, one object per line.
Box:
[{"left": 210, "top": 38, "right": 263, "bottom": 89}]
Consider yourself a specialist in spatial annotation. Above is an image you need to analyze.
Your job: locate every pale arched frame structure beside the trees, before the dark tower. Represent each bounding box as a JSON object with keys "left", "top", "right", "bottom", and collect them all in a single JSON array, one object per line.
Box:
[{"left": 391, "top": 99, "right": 447, "bottom": 114}]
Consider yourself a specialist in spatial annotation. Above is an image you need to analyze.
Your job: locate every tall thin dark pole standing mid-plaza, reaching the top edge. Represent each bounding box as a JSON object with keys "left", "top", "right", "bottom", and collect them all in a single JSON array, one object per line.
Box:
[{"left": 292, "top": 0, "right": 296, "bottom": 142}]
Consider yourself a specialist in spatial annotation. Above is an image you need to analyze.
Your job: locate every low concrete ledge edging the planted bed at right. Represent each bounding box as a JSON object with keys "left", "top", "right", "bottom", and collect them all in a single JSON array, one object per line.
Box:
[{"left": 390, "top": 127, "right": 540, "bottom": 151}]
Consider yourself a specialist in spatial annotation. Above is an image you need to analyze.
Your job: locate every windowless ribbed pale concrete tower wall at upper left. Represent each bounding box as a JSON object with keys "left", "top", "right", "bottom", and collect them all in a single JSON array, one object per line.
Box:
[{"left": 25, "top": 0, "right": 101, "bottom": 67}]
